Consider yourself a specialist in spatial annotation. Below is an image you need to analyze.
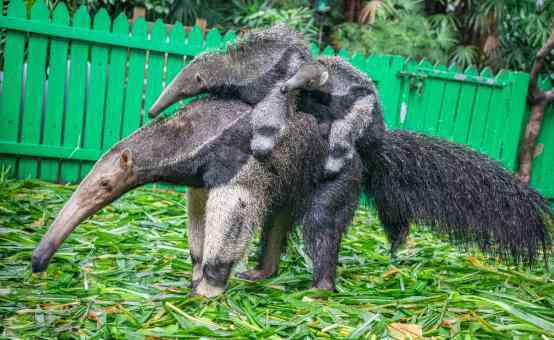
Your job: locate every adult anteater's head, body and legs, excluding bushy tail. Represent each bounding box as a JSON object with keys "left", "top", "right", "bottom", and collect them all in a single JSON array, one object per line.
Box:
[{"left": 32, "top": 92, "right": 362, "bottom": 296}]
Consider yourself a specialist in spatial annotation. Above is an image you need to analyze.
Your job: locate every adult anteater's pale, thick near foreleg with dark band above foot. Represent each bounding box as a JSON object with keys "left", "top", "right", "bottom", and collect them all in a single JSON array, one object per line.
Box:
[{"left": 193, "top": 185, "right": 263, "bottom": 297}]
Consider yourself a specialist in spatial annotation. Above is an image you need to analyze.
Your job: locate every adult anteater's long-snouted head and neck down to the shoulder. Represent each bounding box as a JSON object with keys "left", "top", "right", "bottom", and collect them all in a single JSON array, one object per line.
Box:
[{"left": 32, "top": 98, "right": 251, "bottom": 272}]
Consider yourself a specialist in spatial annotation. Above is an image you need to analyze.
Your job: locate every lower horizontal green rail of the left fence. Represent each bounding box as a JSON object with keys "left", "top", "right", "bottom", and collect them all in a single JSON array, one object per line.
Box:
[{"left": 0, "top": 142, "right": 102, "bottom": 161}]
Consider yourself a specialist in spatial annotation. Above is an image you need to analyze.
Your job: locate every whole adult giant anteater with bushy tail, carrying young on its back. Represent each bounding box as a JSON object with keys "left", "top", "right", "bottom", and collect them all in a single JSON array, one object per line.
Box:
[{"left": 33, "top": 99, "right": 551, "bottom": 296}]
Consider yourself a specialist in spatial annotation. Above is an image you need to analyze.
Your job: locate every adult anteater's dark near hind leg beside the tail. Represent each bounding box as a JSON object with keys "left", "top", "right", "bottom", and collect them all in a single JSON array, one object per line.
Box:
[{"left": 304, "top": 167, "right": 360, "bottom": 290}]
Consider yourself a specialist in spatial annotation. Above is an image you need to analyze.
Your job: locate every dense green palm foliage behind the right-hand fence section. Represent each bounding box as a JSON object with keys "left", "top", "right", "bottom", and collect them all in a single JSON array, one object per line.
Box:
[{"left": 332, "top": 0, "right": 554, "bottom": 71}]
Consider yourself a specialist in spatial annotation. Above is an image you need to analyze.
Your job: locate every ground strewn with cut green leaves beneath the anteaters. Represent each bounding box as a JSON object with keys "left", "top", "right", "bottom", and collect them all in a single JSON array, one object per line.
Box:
[{"left": 0, "top": 181, "right": 554, "bottom": 339}]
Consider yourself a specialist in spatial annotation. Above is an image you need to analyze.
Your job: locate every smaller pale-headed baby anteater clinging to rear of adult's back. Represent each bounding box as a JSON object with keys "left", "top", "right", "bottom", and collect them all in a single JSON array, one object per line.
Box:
[{"left": 283, "top": 57, "right": 385, "bottom": 176}]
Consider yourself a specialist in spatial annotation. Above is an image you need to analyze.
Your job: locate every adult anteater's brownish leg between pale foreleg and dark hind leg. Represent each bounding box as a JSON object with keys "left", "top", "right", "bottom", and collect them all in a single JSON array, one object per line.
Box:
[{"left": 238, "top": 213, "right": 294, "bottom": 281}]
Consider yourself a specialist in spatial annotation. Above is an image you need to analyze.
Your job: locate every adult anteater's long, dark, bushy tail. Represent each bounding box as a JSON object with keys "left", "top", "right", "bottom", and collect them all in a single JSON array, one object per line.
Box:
[{"left": 361, "top": 131, "right": 552, "bottom": 263}]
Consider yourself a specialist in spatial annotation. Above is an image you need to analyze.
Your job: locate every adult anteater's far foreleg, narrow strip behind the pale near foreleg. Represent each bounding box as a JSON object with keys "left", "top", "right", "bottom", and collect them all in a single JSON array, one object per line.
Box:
[{"left": 187, "top": 188, "right": 208, "bottom": 288}]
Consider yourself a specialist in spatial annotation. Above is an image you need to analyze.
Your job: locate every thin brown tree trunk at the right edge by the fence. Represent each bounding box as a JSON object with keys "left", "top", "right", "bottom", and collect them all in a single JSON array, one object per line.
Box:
[{"left": 517, "top": 30, "right": 554, "bottom": 184}]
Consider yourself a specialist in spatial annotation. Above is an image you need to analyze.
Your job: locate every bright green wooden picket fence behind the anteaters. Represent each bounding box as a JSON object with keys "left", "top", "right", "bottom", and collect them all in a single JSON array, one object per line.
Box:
[{"left": 0, "top": 0, "right": 554, "bottom": 198}]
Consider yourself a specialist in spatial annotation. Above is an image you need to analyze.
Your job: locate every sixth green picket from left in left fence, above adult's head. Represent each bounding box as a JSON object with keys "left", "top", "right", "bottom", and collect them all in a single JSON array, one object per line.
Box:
[{"left": 102, "top": 13, "right": 129, "bottom": 150}]
